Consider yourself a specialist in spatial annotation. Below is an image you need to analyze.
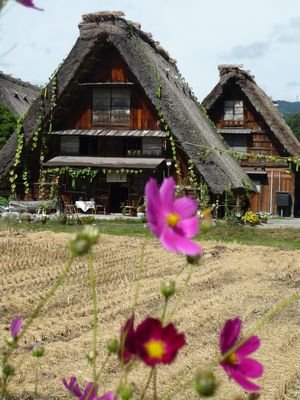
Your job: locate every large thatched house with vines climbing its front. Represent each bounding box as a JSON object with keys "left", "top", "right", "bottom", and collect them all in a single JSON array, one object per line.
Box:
[{"left": 0, "top": 12, "right": 253, "bottom": 211}]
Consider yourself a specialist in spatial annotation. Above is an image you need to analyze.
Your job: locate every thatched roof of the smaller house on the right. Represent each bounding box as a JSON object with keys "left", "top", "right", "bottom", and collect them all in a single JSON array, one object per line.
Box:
[{"left": 202, "top": 64, "right": 300, "bottom": 156}]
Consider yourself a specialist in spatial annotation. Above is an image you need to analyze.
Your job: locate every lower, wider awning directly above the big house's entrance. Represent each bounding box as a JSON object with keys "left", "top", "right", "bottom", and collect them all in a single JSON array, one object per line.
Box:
[{"left": 43, "top": 156, "right": 165, "bottom": 169}]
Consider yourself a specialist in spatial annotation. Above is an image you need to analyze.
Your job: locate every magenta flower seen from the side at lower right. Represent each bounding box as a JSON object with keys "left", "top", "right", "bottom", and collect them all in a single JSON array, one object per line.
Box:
[{"left": 220, "top": 318, "right": 263, "bottom": 392}]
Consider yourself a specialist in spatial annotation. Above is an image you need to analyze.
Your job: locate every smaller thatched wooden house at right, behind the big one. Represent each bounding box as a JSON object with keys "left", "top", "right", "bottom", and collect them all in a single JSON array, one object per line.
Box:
[{"left": 203, "top": 64, "right": 300, "bottom": 216}]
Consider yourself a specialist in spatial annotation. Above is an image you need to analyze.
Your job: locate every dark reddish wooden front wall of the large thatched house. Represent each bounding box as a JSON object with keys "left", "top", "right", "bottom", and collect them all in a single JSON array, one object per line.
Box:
[{"left": 41, "top": 46, "right": 174, "bottom": 212}]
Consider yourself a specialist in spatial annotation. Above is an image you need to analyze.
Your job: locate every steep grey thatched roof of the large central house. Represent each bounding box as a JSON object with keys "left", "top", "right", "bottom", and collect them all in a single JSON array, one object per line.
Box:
[{"left": 0, "top": 12, "right": 255, "bottom": 193}]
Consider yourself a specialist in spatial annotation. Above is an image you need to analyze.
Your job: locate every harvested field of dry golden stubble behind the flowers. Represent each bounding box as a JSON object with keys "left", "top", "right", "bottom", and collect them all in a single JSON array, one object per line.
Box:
[{"left": 0, "top": 231, "right": 300, "bottom": 400}]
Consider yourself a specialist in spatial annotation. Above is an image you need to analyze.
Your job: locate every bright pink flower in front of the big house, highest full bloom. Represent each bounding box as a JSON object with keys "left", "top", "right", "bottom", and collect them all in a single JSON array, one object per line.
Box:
[{"left": 145, "top": 178, "right": 202, "bottom": 256}]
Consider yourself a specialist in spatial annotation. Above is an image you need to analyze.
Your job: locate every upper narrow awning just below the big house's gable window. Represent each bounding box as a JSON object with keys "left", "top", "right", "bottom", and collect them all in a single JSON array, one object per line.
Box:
[{"left": 51, "top": 129, "right": 167, "bottom": 138}]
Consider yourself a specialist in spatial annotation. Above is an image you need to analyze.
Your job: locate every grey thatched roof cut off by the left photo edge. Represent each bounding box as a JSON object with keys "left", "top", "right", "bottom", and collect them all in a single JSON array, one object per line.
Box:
[{"left": 0, "top": 72, "right": 40, "bottom": 116}]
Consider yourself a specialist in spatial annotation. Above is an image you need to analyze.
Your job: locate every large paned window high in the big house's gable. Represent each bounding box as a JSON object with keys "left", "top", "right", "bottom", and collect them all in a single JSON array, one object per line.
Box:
[{"left": 92, "top": 87, "right": 130, "bottom": 126}]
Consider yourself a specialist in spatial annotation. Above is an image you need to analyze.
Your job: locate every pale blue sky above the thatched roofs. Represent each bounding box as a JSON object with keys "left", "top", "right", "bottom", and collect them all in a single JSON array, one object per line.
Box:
[{"left": 0, "top": 0, "right": 300, "bottom": 101}]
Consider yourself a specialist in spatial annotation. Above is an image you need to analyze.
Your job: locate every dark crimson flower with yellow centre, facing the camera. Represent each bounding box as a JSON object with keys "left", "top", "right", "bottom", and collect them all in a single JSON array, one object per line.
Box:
[{"left": 135, "top": 318, "right": 185, "bottom": 367}]
